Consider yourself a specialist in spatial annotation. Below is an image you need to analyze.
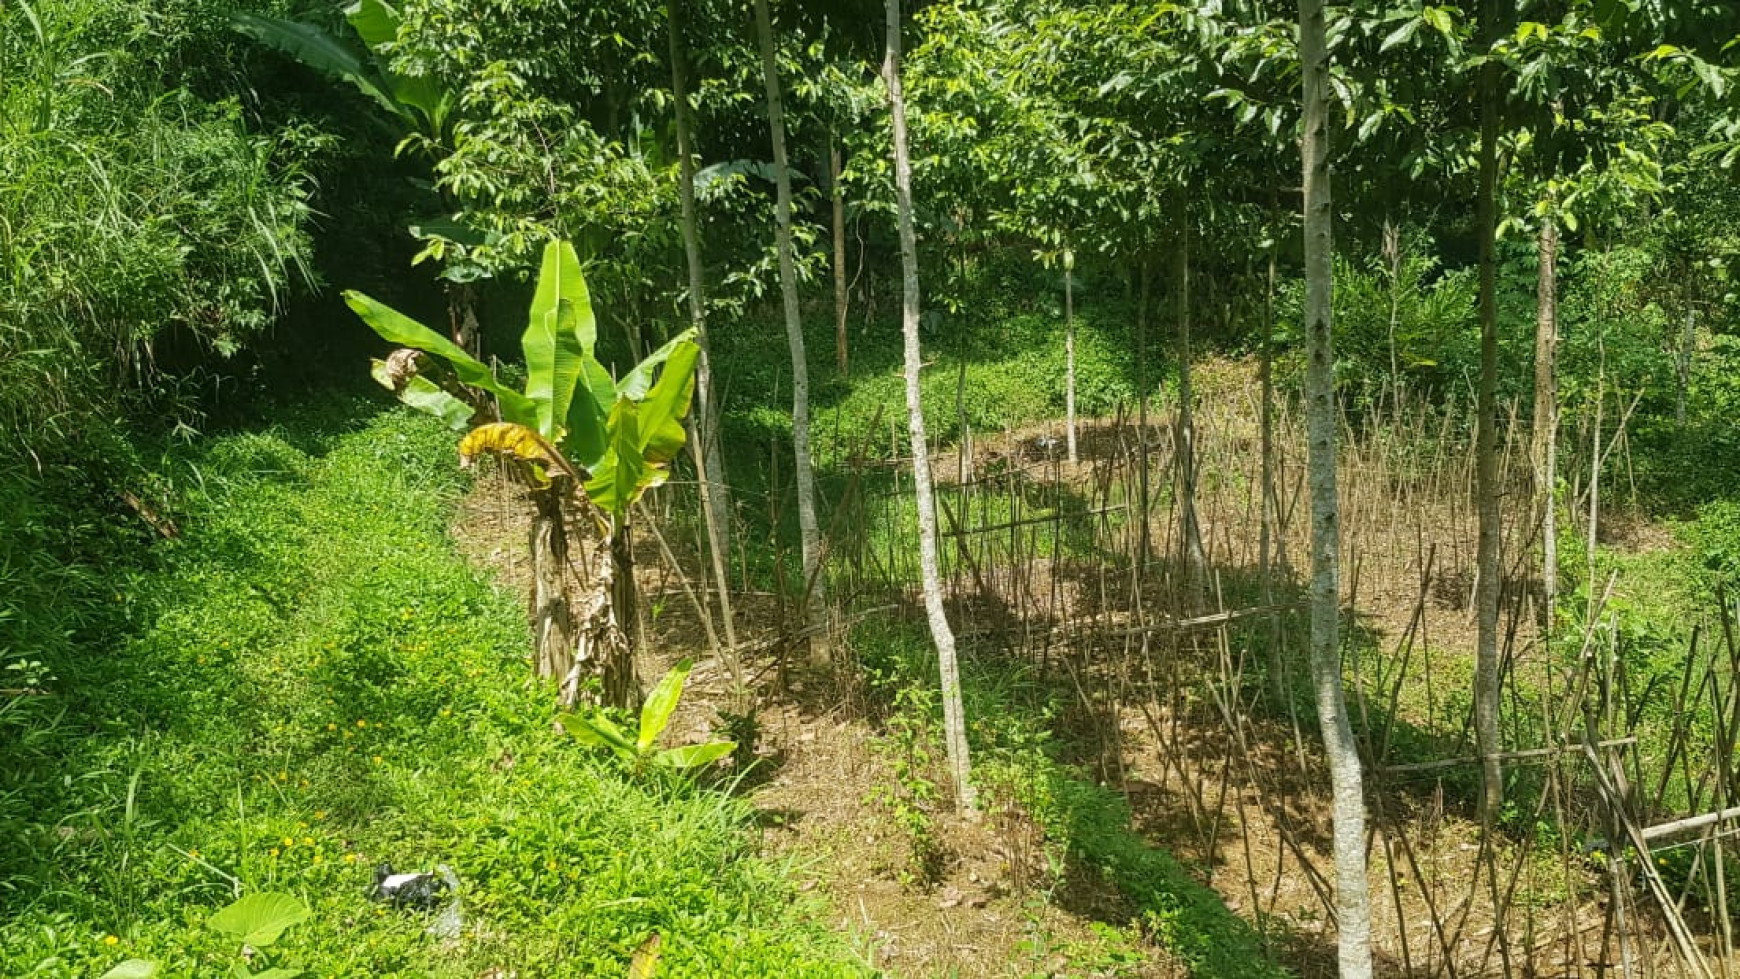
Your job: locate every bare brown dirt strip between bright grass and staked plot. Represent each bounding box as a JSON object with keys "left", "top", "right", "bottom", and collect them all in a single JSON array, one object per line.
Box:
[{"left": 451, "top": 473, "right": 1187, "bottom": 979}]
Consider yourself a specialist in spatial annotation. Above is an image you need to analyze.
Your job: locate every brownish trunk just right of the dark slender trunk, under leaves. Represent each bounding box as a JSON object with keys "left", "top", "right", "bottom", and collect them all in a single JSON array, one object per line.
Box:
[{"left": 1533, "top": 214, "right": 1559, "bottom": 636}]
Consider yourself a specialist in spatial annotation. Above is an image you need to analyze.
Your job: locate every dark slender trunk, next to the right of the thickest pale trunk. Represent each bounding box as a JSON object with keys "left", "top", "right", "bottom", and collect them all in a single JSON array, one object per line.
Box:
[{"left": 1474, "top": 0, "right": 1505, "bottom": 819}]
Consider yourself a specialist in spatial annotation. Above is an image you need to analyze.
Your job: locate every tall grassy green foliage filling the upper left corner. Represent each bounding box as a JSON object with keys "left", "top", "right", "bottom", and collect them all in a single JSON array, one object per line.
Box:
[{"left": 0, "top": 0, "right": 327, "bottom": 452}]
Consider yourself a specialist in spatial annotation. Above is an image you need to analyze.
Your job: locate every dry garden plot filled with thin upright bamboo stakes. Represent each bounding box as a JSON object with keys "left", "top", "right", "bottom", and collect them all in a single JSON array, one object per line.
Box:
[{"left": 755, "top": 377, "right": 1740, "bottom": 979}]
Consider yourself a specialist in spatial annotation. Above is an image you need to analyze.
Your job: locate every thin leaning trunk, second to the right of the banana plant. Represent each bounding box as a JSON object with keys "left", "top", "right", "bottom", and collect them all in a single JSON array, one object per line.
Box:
[{"left": 755, "top": 0, "right": 833, "bottom": 664}]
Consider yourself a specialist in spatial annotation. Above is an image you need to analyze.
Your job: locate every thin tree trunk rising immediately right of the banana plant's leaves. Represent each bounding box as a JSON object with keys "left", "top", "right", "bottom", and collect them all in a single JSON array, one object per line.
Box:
[{"left": 665, "top": 0, "right": 745, "bottom": 692}]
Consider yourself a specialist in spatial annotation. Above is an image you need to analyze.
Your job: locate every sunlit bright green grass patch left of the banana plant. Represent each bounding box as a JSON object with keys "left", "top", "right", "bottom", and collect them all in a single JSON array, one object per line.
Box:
[{"left": 0, "top": 405, "right": 870, "bottom": 977}]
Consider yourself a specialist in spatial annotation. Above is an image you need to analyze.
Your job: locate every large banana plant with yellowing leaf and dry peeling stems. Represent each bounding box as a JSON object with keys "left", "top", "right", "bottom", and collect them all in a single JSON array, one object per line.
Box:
[{"left": 345, "top": 242, "right": 699, "bottom": 708}]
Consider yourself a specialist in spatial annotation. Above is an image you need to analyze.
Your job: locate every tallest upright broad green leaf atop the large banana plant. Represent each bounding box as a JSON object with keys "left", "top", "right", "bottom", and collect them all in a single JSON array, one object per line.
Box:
[{"left": 520, "top": 242, "right": 597, "bottom": 440}]
